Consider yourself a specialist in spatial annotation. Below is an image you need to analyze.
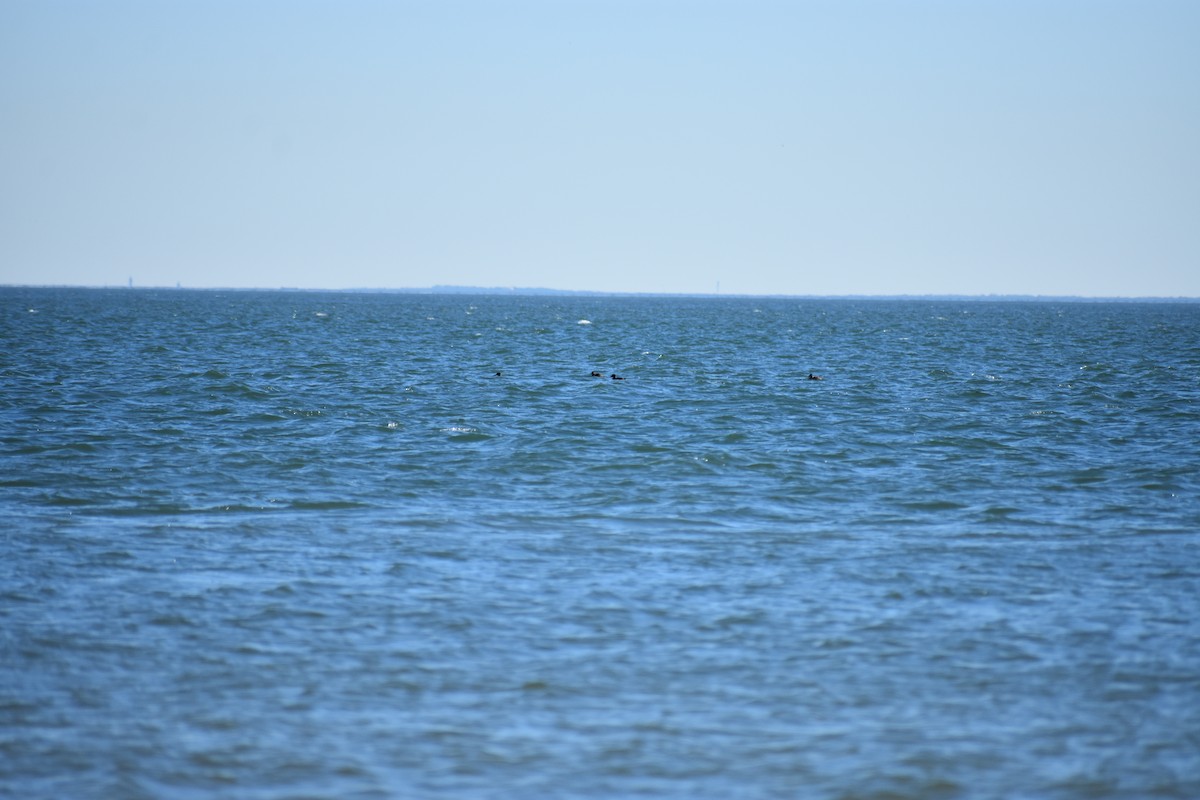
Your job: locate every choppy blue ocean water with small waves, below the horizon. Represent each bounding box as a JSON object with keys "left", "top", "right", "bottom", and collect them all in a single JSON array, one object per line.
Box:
[{"left": 0, "top": 288, "right": 1200, "bottom": 800}]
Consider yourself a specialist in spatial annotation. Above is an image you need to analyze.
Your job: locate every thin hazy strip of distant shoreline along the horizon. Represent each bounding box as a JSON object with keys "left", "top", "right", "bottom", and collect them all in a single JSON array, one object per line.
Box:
[{"left": 0, "top": 283, "right": 1200, "bottom": 303}]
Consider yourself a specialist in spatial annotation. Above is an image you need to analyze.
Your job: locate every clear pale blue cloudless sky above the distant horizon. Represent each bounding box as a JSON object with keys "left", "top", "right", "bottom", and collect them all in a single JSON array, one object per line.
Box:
[{"left": 0, "top": 0, "right": 1200, "bottom": 296}]
